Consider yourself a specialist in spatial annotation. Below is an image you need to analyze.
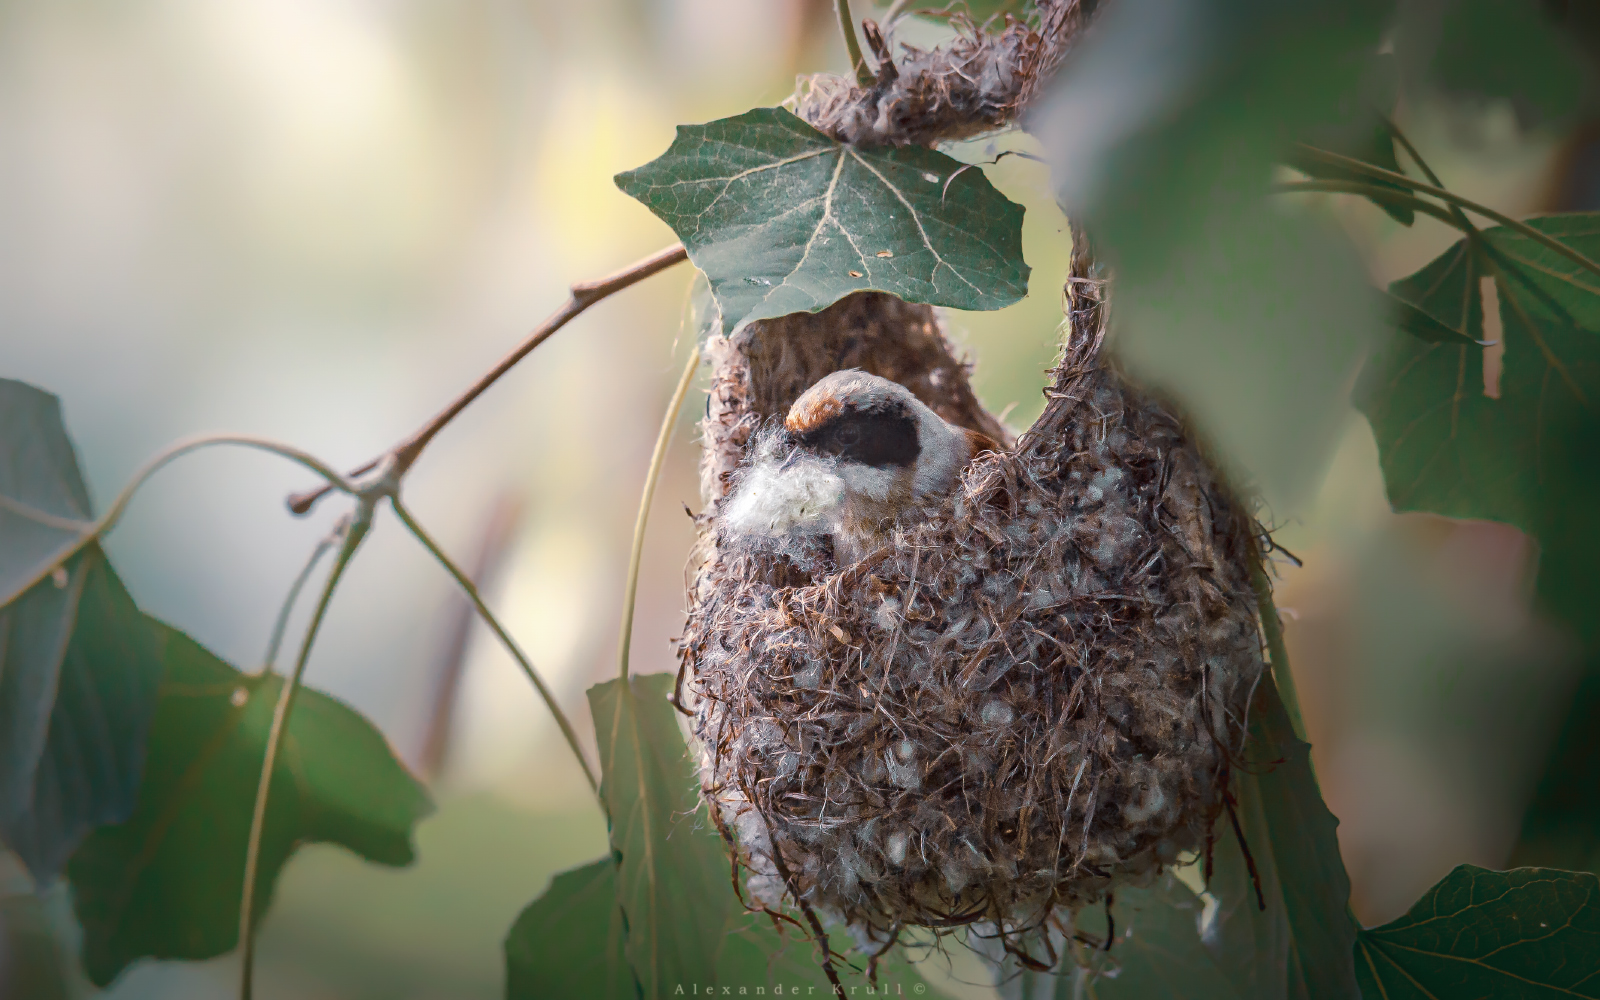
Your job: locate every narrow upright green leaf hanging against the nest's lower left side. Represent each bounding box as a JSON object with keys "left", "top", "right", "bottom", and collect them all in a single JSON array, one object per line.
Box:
[{"left": 589, "top": 674, "right": 738, "bottom": 1000}]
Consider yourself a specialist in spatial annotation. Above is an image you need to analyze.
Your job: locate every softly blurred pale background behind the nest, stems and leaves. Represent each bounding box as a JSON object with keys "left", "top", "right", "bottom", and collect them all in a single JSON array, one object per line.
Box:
[{"left": 0, "top": 0, "right": 1600, "bottom": 1000}]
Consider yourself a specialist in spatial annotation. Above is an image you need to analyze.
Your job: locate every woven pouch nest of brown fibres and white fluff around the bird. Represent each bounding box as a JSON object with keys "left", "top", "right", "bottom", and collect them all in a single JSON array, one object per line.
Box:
[{"left": 680, "top": 257, "right": 1262, "bottom": 950}]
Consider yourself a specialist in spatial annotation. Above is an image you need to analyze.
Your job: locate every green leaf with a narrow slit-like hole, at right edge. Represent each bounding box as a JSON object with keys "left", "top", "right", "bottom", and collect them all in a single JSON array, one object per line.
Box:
[{"left": 1355, "top": 214, "right": 1600, "bottom": 558}]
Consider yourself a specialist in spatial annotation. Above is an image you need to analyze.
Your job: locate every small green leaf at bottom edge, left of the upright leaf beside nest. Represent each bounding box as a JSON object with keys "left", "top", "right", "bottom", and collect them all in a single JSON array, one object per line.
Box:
[{"left": 506, "top": 858, "right": 638, "bottom": 1000}]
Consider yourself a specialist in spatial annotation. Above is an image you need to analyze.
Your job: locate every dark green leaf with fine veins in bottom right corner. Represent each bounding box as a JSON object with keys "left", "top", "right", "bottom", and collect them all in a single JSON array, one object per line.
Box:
[{"left": 1355, "top": 864, "right": 1600, "bottom": 1000}]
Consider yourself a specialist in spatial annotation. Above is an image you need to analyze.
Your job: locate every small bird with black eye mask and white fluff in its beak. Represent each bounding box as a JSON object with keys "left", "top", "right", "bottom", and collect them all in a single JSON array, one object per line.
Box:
[{"left": 720, "top": 368, "right": 998, "bottom": 566}]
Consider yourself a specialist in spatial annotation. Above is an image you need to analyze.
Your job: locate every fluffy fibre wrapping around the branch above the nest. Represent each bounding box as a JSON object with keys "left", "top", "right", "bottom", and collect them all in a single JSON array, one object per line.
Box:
[{"left": 795, "top": 0, "right": 1094, "bottom": 146}]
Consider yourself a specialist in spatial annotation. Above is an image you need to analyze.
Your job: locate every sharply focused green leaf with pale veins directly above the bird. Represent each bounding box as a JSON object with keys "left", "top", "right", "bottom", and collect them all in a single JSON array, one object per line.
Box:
[{"left": 604, "top": 107, "right": 1029, "bottom": 331}]
